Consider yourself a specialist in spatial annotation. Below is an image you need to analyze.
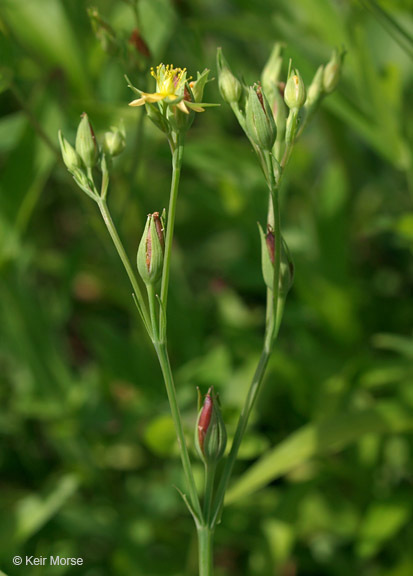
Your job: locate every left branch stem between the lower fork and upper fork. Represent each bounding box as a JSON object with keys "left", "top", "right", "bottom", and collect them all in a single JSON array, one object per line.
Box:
[{"left": 154, "top": 341, "right": 203, "bottom": 522}]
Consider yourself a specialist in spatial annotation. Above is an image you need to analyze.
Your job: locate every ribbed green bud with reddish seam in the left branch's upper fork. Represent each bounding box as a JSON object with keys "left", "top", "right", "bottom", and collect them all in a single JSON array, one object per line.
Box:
[{"left": 137, "top": 212, "right": 165, "bottom": 285}]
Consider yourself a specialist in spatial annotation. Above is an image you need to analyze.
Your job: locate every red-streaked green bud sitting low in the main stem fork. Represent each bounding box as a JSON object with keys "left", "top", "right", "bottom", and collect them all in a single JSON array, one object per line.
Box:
[{"left": 195, "top": 387, "right": 227, "bottom": 465}]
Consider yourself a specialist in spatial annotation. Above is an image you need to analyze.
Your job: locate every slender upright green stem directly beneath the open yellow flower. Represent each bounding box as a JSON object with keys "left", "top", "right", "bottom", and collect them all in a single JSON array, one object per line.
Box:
[{"left": 160, "top": 134, "right": 184, "bottom": 341}]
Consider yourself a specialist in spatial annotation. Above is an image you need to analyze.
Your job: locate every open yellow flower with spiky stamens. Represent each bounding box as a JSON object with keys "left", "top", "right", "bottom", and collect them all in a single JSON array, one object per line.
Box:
[{"left": 129, "top": 64, "right": 204, "bottom": 114}]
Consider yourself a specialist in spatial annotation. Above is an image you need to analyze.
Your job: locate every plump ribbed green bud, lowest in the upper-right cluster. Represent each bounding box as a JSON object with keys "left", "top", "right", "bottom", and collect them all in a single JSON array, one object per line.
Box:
[{"left": 246, "top": 85, "right": 277, "bottom": 151}]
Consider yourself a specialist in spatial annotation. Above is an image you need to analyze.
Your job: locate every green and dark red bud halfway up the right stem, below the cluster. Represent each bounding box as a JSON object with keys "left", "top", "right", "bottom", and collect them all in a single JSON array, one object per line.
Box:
[{"left": 258, "top": 224, "right": 294, "bottom": 297}]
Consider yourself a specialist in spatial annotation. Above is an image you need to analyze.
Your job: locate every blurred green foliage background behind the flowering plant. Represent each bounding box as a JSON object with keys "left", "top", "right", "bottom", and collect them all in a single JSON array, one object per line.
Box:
[{"left": 0, "top": 0, "right": 413, "bottom": 576}]
